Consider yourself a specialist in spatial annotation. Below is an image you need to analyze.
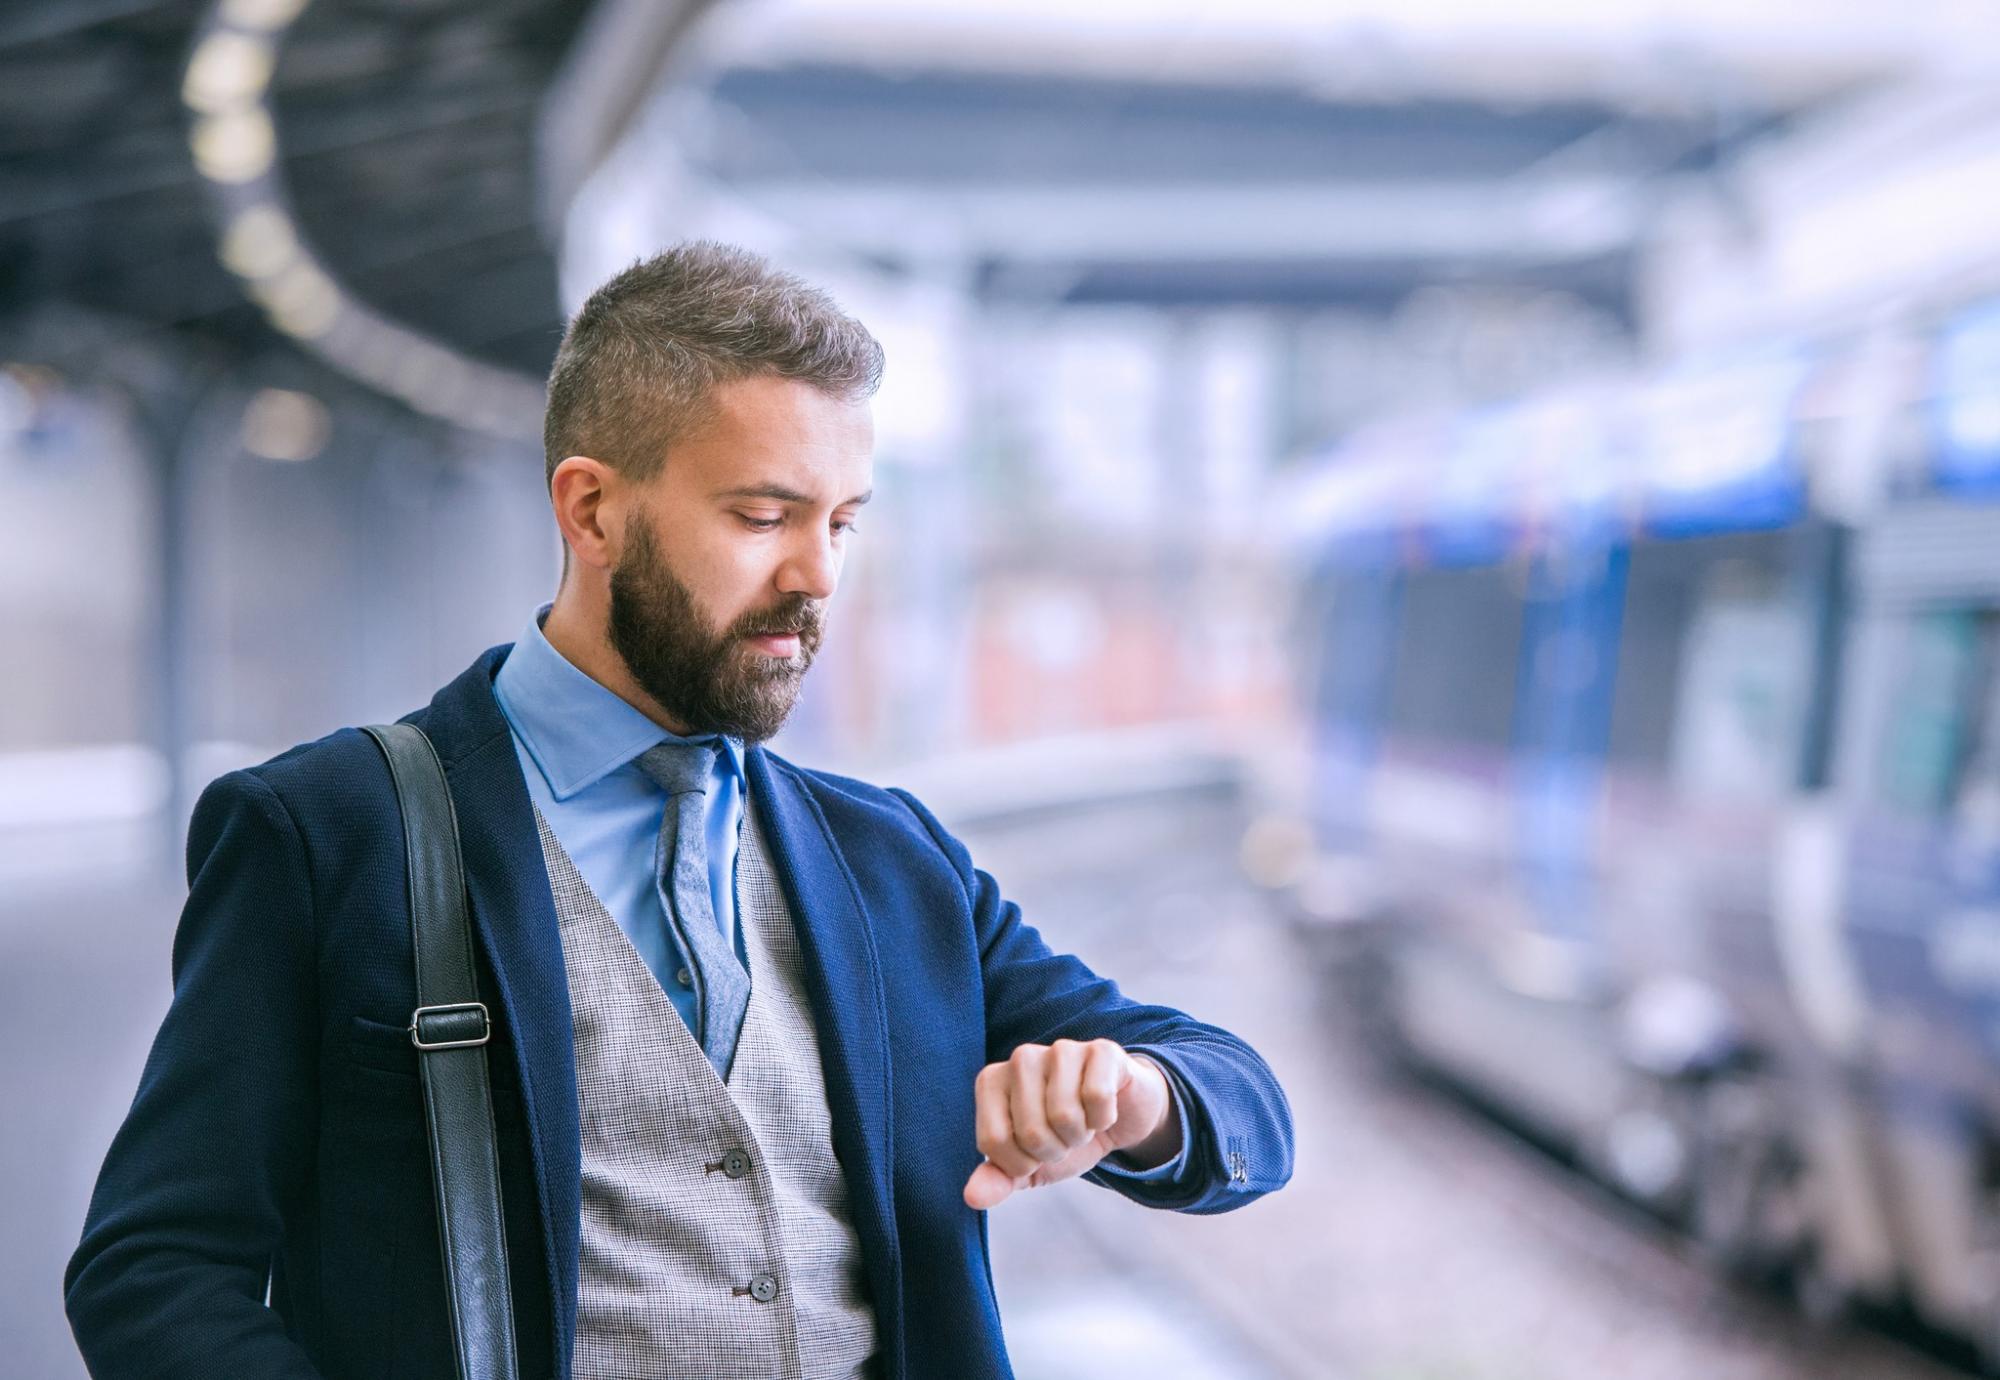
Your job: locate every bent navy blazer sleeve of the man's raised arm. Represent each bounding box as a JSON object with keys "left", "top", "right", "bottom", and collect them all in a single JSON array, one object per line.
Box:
[{"left": 894, "top": 790, "right": 1292, "bottom": 1212}]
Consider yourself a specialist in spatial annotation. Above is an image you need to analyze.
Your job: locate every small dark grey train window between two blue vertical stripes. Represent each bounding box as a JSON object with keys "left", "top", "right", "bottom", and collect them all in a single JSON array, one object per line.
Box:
[{"left": 1388, "top": 566, "right": 1526, "bottom": 750}]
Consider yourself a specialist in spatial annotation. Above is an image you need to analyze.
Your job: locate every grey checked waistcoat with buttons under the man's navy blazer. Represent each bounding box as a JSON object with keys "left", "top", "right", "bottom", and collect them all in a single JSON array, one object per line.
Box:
[{"left": 534, "top": 796, "right": 874, "bottom": 1380}]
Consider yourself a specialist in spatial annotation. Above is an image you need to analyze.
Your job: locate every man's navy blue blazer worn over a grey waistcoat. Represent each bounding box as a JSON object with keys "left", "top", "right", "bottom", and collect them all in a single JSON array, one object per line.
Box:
[{"left": 64, "top": 646, "right": 1292, "bottom": 1380}]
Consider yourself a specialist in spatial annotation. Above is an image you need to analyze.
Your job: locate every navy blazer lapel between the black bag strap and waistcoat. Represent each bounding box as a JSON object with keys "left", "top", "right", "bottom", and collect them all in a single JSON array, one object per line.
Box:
[{"left": 412, "top": 644, "right": 582, "bottom": 1376}]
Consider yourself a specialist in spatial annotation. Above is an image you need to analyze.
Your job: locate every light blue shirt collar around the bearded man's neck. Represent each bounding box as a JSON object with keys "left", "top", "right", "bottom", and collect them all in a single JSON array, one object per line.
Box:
[{"left": 494, "top": 604, "right": 744, "bottom": 800}]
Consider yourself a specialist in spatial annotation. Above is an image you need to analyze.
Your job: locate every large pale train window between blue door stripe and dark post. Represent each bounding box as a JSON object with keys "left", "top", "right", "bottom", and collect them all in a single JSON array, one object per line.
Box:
[{"left": 1608, "top": 532, "right": 1812, "bottom": 800}]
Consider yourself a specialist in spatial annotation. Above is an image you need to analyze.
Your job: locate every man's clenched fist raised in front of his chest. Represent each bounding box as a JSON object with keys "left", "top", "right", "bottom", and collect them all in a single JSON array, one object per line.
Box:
[{"left": 966, "top": 1040, "right": 1180, "bottom": 1208}]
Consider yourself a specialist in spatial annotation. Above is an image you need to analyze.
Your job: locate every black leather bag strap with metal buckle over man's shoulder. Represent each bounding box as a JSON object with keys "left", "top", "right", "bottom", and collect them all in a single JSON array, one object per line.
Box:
[{"left": 364, "top": 724, "right": 518, "bottom": 1380}]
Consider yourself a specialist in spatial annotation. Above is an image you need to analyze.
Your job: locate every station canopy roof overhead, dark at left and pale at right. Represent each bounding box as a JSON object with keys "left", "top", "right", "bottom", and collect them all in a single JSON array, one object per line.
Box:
[{"left": 0, "top": 0, "right": 1968, "bottom": 414}]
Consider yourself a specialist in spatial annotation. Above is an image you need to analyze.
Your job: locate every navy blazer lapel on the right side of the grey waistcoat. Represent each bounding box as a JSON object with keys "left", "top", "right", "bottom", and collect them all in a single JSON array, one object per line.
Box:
[{"left": 744, "top": 746, "right": 902, "bottom": 1376}]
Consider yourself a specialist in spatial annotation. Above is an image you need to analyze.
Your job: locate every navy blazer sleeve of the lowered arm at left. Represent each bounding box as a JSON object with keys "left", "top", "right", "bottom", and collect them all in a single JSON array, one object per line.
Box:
[{"left": 64, "top": 772, "right": 318, "bottom": 1380}]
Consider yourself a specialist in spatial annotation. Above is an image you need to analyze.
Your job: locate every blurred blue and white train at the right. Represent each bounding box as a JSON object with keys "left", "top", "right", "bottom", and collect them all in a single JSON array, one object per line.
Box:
[{"left": 1294, "top": 296, "right": 2000, "bottom": 1366}]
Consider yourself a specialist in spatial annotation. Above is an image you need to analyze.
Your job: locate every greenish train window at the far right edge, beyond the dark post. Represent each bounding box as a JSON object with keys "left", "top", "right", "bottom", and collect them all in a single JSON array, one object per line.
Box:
[{"left": 1874, "top": 608, "right": 1994, "bottom": 816}]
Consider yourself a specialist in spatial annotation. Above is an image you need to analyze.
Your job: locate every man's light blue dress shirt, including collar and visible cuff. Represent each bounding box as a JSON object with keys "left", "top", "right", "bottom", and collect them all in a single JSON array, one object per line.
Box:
[{"left": 494, "top": 604, "right": 1190, "bottom": 1180}]
